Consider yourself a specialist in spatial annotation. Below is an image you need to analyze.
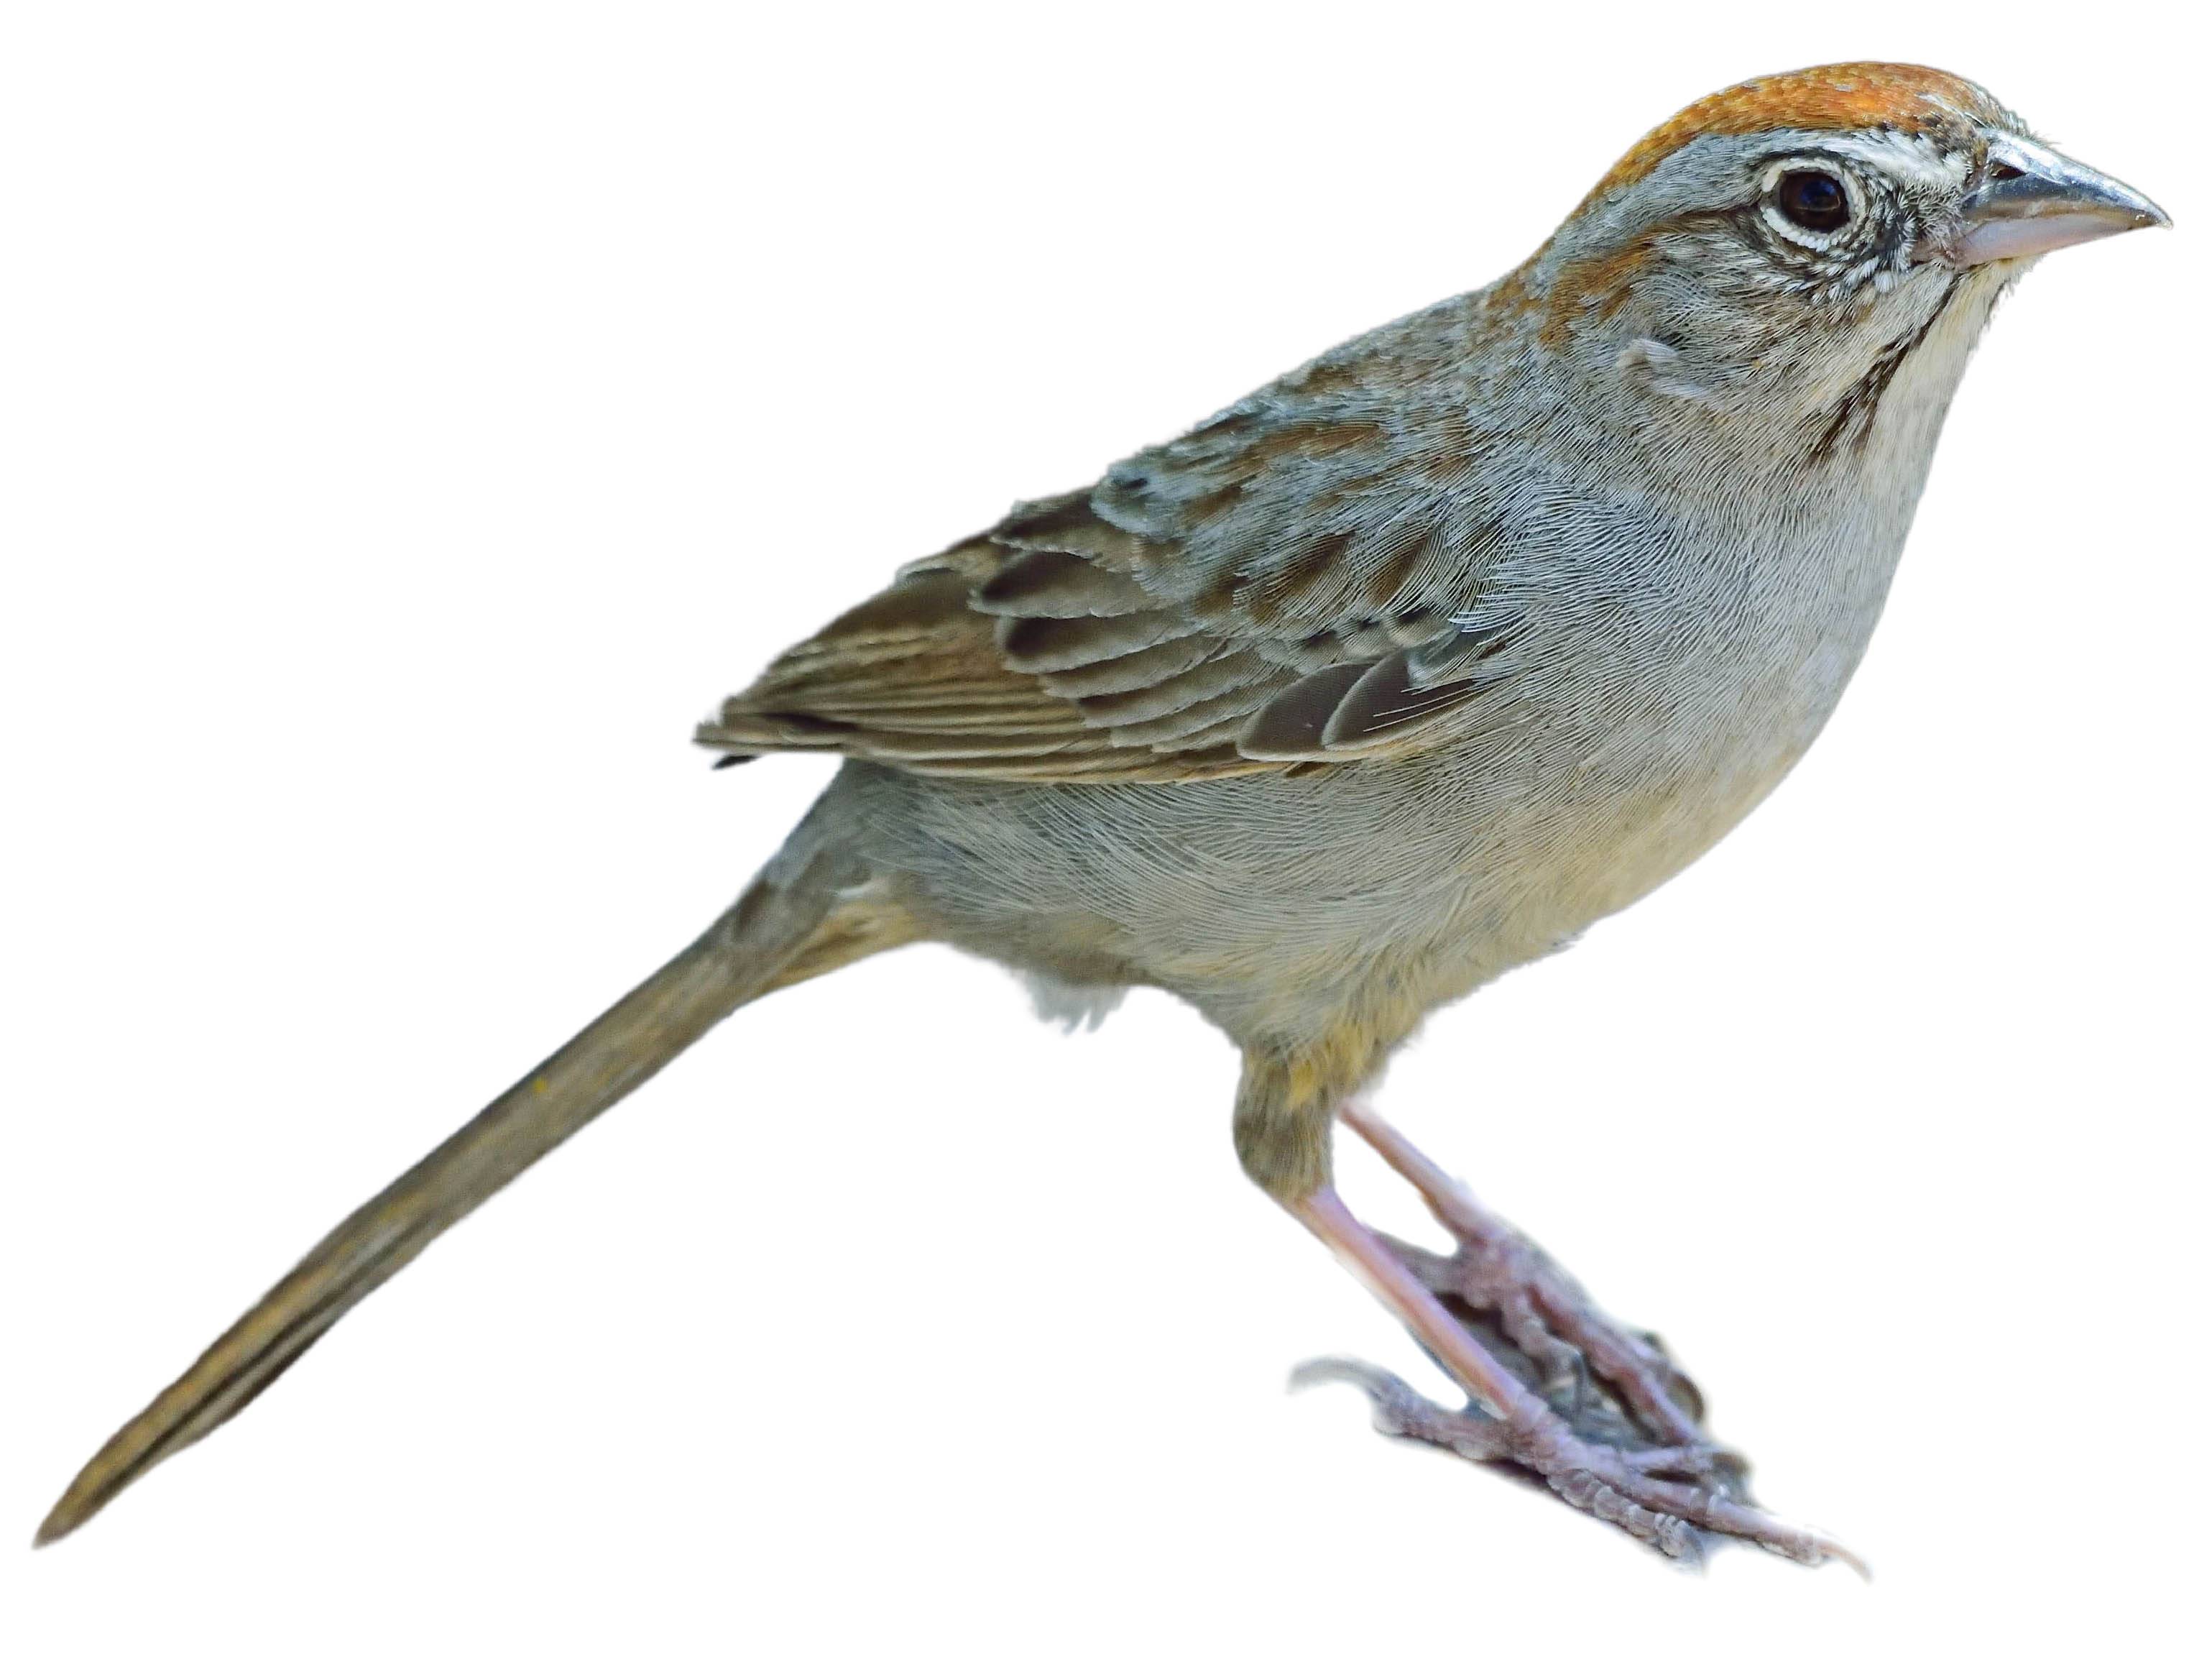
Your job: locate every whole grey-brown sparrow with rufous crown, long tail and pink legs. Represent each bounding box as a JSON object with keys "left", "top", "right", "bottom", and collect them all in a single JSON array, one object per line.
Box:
[{"left": 37, "top": 62, "right": 2167, "bottom": 1564}]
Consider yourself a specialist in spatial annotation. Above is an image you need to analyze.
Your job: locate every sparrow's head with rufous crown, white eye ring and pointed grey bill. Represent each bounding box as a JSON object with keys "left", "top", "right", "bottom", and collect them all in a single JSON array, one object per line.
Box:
[{"left": 1518, "top": 64, "right": 2167, "bottom": 454}]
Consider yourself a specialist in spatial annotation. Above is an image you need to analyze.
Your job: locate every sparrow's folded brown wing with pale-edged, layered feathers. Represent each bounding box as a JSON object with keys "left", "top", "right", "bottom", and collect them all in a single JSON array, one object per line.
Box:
[{"left": 699, "top": 336, "right": 1522, "bottom": 783}]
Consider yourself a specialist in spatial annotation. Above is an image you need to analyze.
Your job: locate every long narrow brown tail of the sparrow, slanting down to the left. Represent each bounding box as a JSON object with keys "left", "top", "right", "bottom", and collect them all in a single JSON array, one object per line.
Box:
[{"left": 37, "top": 830, "right": 913, "bottom": 1544}]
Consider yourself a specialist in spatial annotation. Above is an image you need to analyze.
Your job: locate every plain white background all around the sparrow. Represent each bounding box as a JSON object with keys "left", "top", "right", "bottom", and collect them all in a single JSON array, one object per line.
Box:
[{"left": 0, "top": 0, "right": 2212, "bottom": 1657}]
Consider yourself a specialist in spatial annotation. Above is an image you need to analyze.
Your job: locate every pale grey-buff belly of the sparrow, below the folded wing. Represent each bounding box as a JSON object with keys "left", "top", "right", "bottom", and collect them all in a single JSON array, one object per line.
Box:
[{"left": 843, "top": 559, "right": 1871, "bottom": 1037}]
